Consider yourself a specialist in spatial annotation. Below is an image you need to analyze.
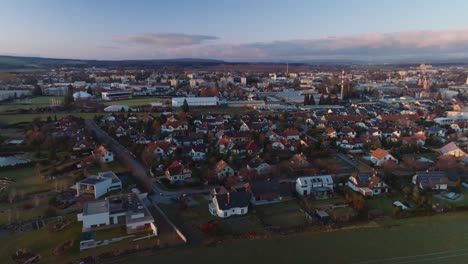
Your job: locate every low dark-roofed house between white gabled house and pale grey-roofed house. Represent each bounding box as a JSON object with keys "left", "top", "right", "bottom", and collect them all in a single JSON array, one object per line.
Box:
[{"left": 246, "top": 181, "right": 293, "bottom": 205}]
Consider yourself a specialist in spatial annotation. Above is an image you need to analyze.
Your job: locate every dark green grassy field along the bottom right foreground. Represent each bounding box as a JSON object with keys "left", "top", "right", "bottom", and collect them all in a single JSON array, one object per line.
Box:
[{"left": 122, "top": 212, "right": 468, "bottom": 264}]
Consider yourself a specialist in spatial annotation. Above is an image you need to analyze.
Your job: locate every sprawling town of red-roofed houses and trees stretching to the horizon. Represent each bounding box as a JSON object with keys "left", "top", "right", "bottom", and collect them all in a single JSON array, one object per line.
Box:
[{"left": 0, "top": 62, "right": 468, "bottom": 263}]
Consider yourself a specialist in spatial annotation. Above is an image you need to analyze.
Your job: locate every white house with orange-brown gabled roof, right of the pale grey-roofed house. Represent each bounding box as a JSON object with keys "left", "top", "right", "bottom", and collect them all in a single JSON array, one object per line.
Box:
[{"left": 346, "top": 173, "right": 389, "bottom": 196}]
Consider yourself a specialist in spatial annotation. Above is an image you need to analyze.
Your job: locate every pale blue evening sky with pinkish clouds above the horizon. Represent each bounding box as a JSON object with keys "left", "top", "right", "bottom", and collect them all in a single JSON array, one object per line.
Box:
[{"left": 0, "top": 0, "right": 468, "bottom": 61}]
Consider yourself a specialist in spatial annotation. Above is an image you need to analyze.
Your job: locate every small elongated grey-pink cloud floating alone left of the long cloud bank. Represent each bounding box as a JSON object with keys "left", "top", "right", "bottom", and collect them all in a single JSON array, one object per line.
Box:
[{"left": 119, "top": 33, "right": 218, "bottom": 47}]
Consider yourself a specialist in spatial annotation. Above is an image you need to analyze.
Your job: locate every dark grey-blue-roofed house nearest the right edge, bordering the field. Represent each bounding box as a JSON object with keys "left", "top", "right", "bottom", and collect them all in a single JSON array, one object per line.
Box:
[{"left": 412, "top": 171, "right": 455, "bottom": 191}]
